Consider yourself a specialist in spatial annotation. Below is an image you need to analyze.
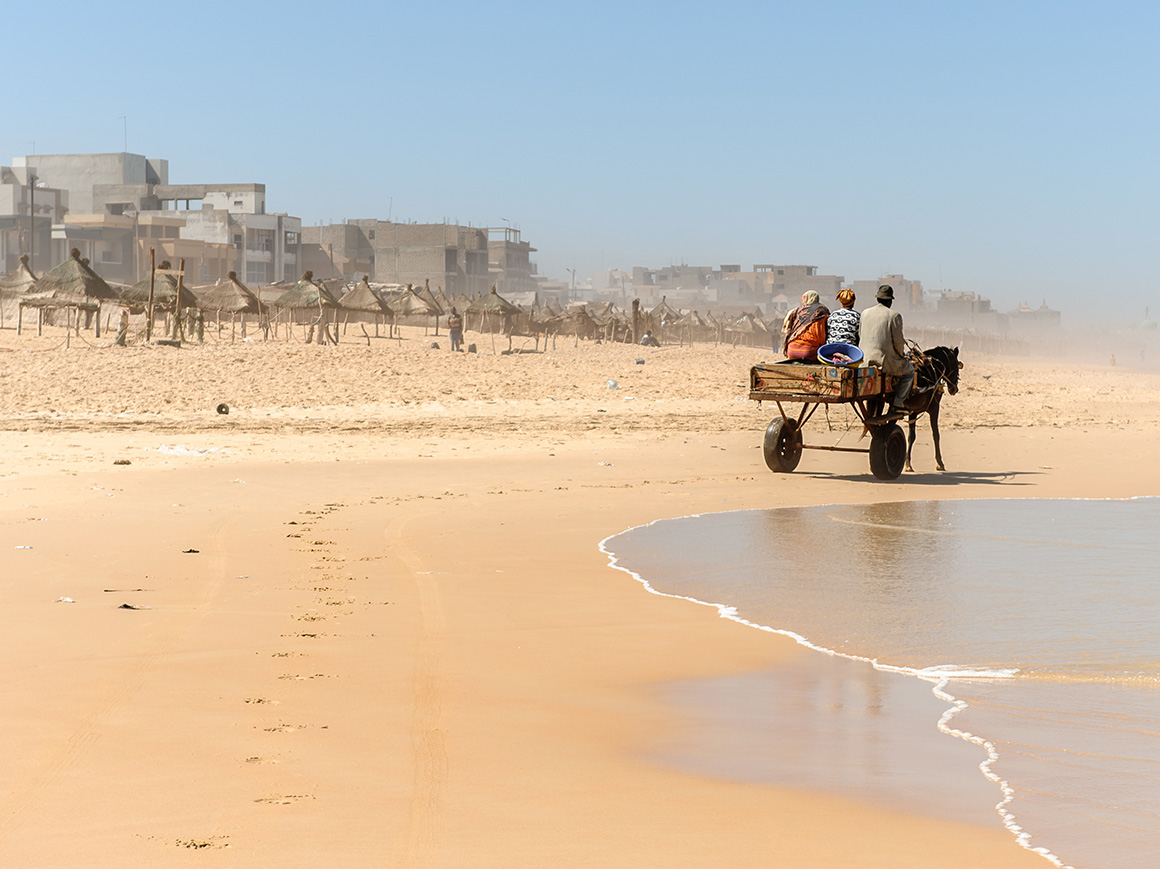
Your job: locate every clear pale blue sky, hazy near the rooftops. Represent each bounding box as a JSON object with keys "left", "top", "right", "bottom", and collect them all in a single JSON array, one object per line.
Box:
[{"left": 0, "top": 0, "right": 1160, "bottom": 321}]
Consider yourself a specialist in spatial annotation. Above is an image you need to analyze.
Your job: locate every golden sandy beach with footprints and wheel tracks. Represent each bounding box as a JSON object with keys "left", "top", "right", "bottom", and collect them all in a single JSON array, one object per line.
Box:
[{"left": 0, "top": 330, "right": 1160, "bottom": 867}]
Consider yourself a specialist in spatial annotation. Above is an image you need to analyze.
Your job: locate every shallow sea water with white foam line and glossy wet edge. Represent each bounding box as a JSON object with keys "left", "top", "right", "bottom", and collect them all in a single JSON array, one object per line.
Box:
[{"left": 603, "top": 498, "right": 1160, "bottom": 869}]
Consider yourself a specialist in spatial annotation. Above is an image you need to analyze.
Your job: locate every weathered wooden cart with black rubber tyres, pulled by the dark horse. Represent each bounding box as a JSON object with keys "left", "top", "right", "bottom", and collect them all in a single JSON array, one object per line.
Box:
[{"left": 749, "top": 362, "right": 906, "bottom": 480}]
